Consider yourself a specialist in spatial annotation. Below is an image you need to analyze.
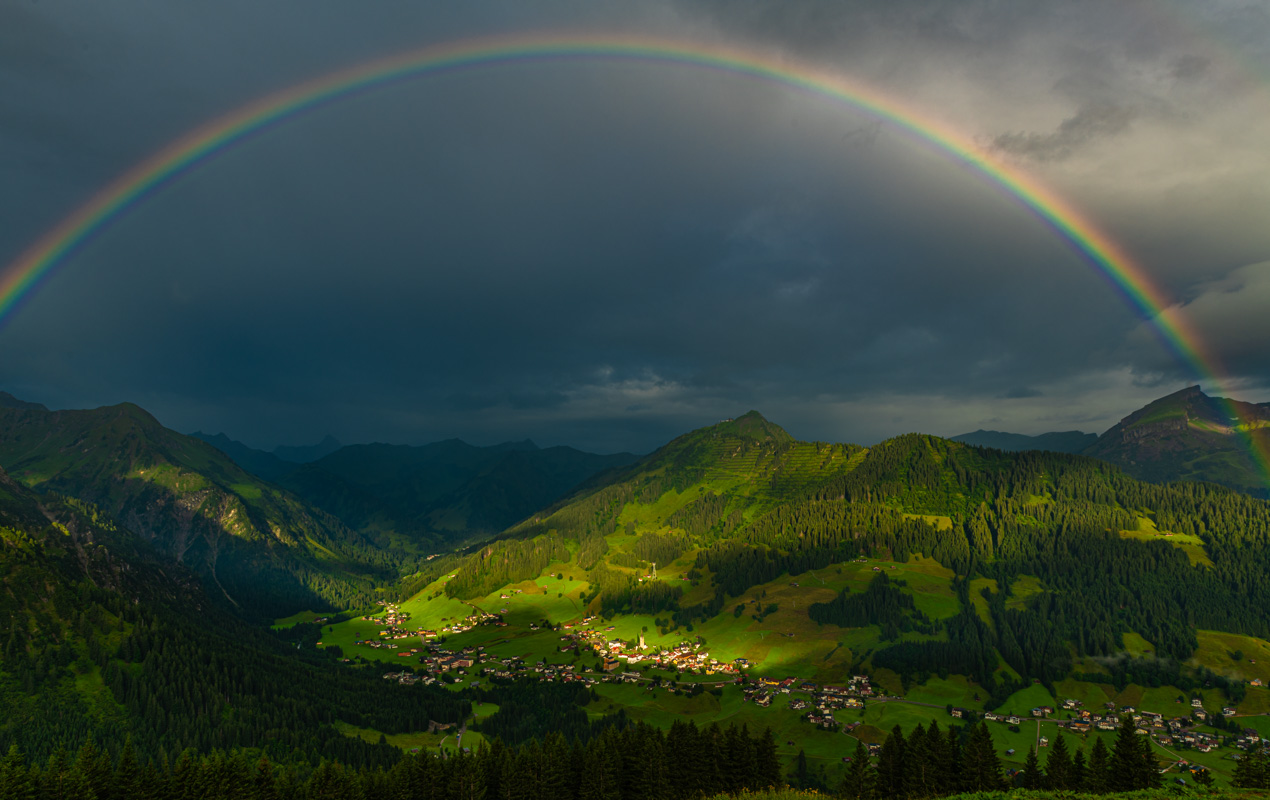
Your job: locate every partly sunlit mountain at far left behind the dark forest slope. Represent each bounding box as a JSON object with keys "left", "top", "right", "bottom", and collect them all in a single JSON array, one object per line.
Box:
[{"left": 0, "top": 404, "right": 399, "bottom": 618}]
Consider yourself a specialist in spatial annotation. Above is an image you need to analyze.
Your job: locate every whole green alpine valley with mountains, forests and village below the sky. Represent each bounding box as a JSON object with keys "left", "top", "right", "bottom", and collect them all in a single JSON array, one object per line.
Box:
[{"left": 0, "top": 389, "right": 1270, "bottom": 800}]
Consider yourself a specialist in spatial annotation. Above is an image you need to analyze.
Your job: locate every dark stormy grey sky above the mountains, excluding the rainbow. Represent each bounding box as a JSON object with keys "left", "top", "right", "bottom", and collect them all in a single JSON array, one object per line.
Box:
[{"left": 0, "top": 0, "right": 1270, "bottom": 451}]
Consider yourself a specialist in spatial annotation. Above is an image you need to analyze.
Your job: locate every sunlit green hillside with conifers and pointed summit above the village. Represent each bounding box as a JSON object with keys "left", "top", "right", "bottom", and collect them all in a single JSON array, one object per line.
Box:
[{"left": 429, "top": 413, "right": 1270, "bottom": 698}]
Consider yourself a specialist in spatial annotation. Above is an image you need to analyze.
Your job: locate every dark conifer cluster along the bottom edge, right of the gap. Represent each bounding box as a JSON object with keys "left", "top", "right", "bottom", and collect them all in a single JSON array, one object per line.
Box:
[{"left": 839, "top": 717, "right": 1168, "bottom": 800}]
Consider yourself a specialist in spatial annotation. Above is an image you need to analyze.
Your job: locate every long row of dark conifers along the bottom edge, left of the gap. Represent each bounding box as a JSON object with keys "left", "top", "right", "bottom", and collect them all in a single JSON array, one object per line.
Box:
[{"left": 0, "top": 721, "right": 784, "bottom": 800}]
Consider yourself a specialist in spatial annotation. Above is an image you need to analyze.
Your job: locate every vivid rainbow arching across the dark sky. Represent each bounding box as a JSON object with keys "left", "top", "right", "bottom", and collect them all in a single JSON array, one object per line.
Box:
[{"left": 0, "top": 33, "right": 1270, "bottom": 486}]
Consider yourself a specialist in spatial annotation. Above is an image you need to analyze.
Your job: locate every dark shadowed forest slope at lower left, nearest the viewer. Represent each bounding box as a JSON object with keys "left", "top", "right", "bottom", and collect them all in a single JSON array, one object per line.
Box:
[{"left": 0, "top": 472, "right": 470, "bottom": 766}]
